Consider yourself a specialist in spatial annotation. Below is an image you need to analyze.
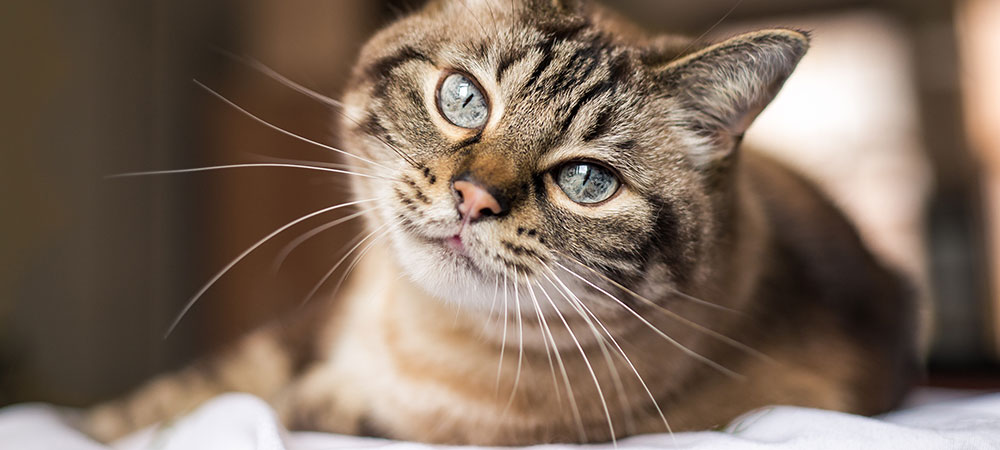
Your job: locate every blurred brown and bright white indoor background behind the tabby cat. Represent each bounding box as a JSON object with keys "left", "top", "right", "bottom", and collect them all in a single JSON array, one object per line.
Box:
[{"left": 0, "top": 0, "right": 1000, "bottom": 406}]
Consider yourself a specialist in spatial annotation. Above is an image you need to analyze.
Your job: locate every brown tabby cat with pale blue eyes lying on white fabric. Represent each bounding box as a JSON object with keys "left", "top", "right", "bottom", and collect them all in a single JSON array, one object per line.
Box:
[{"left": 82, "top": 0, "right": 919, "bottom": 445}]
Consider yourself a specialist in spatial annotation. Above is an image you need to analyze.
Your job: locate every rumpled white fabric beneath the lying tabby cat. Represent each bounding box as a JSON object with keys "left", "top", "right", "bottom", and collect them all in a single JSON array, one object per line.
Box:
[{"left": 0, "top": 392, "right": 1000, "bottom": 450}]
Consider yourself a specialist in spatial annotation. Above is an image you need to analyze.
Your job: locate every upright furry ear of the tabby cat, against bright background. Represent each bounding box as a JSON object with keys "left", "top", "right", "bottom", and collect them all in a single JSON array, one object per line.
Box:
[{"left": 650, "top": 29, "right": 809, "bottom": 163}]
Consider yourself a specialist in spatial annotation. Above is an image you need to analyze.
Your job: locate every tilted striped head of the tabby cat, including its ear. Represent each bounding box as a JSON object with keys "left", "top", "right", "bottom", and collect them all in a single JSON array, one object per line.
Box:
[{"left": 341, "top": 0, "right": 808, "bottom": 310}]
